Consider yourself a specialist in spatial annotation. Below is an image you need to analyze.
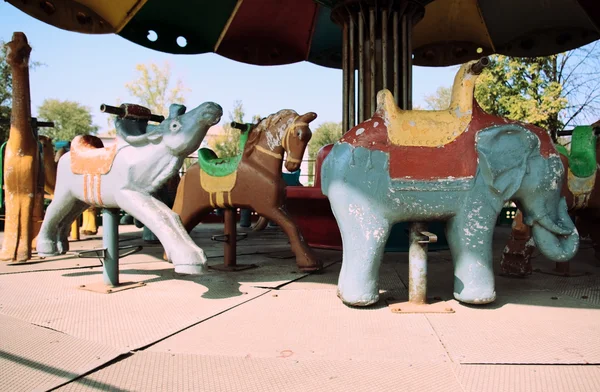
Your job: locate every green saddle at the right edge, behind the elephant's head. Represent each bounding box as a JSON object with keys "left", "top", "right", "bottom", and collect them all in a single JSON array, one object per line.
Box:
[{"left": 557, "top": 126, "right": 597, "bottom": 178}]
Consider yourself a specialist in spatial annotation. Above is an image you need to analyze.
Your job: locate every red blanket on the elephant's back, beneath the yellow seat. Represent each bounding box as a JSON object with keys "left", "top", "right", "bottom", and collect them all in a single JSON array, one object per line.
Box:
[{"left": 340, "top": 102, "right": 556, "bottom": 180}]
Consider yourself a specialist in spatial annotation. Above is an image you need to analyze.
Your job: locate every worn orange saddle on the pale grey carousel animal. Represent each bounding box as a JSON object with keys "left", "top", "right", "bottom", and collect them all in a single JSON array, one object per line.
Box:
[{"left": 71, "top": 135, "right": 117, "bottom": 174}]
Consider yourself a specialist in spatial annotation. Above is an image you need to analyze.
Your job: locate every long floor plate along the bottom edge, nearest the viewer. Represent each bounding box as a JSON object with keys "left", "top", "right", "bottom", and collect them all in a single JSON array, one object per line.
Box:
[{"left": 58, "top": 351, "right": 463, "bottom": 392}]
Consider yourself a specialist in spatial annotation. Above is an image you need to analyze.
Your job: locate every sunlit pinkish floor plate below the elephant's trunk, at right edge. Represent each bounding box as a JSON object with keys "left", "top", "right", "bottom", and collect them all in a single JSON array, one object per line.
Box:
[{"left": 427, "top": 291, "right": 600, "bottom": 364}]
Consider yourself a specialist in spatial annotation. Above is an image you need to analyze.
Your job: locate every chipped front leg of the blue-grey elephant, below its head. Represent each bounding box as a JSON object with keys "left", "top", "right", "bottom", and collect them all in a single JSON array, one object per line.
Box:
[{"left": 446, "top": 207, "right": 497, "bottom": 304}]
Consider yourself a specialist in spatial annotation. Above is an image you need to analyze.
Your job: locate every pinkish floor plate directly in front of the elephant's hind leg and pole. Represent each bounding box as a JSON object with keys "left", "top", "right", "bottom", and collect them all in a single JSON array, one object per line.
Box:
[{"left": 148, "top": 290, "right": 449, "bottom": 363}]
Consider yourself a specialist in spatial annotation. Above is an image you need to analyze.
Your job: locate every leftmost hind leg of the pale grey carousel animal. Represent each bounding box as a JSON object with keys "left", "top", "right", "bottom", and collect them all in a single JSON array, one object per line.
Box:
[{"left": 37, "top": 190, "right": 82, "bottom": 256}]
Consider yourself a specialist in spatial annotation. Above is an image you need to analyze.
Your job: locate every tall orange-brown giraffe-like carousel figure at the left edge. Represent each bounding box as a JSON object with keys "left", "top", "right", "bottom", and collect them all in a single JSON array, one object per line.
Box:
[{"left": 0, "top": 32, "right": 43, "bottom": 261}]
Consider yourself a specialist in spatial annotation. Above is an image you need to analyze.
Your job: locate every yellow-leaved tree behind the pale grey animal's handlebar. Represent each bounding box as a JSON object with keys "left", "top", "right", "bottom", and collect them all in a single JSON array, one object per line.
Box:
[{"left": 125, "top": 62, "right": 190, "bottom": 117}]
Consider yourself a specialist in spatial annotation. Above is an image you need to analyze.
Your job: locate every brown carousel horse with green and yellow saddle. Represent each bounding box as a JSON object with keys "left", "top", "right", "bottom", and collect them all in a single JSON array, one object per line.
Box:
[{"left": 173, "top": 109, "right": 322, "bottom": 271}]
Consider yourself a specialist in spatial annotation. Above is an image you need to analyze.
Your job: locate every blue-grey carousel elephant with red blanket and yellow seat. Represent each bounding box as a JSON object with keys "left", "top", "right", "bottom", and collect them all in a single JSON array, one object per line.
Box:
[{"left": 321, "top": 62, "right": 579, "bottom": 306}]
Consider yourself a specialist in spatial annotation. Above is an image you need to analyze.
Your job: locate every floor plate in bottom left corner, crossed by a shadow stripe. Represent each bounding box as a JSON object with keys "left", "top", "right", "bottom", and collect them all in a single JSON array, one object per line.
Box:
[{"left": 0, "top": 315, "right": 122, "bottom": 392}]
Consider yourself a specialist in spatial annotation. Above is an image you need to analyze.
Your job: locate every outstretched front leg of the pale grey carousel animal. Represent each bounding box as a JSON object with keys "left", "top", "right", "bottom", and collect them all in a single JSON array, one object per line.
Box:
[{"left": 115, "top": 190, "right": 206, "bottom": 275}]
